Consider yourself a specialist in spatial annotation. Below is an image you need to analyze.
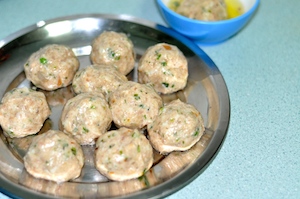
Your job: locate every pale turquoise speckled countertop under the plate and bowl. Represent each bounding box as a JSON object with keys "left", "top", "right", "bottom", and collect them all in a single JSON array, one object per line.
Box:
[{"left": 0, "top": 0, "right": 300, "bottom": 199}]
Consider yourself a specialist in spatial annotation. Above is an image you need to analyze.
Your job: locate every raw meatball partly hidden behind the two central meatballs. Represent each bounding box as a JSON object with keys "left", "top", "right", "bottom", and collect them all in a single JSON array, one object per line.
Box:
[{"left": 72, "top": 65, "right": 127, "bottom": 96}]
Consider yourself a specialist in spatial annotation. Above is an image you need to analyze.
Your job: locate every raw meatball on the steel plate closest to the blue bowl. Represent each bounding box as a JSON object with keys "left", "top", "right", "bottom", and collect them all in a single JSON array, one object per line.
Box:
[{"left": 138, "top": 43, "right": 188, "bottom": 94}]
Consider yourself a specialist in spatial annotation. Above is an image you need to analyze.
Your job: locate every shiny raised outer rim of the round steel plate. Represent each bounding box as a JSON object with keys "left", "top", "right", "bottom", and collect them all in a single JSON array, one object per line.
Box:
[{"left": 0, "top": 13, "right": 230, "bottom": 198}]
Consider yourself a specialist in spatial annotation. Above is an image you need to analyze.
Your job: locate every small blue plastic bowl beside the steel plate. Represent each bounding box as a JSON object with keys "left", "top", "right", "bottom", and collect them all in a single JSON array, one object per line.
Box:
[{"left": 157, "top": 0, "right": 260, "bottom": 44}]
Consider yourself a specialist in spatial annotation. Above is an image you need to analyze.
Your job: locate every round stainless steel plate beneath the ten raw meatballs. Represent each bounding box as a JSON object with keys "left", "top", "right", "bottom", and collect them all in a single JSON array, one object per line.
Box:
[{"left": 0, "top": 14, "right": 230, "bottom": 198}]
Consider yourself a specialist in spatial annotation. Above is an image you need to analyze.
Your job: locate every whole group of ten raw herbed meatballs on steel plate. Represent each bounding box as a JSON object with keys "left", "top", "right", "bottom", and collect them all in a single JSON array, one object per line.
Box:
[{"left": 0, "top": 31, "right": 204, "bottom": 183}]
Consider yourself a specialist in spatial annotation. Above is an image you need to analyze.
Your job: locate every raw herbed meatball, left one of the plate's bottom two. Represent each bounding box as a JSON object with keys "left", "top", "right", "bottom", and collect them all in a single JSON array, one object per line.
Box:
[{"left": 24, "top": 130, "right": 84, "bottom": 182}]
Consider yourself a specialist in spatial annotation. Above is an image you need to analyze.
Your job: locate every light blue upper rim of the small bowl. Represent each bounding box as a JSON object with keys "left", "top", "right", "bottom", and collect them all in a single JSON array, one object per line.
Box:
[{"left": 157, "top": 0, "right": 260, "bottom": 25}]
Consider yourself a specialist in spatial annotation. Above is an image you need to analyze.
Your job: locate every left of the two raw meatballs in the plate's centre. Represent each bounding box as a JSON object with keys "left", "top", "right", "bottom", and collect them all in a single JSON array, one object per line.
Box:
[{"left": 61, "top": 93, "right": 112, "bottom": 145}]
